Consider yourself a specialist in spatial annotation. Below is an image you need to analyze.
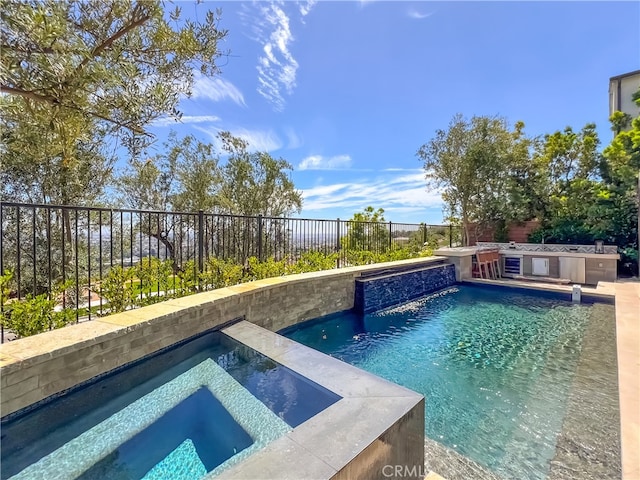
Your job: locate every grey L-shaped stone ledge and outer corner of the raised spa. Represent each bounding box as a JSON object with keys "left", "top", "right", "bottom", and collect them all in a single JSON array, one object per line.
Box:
[{"left": 216, "top": 321, "right": 424, "bottom": 480}]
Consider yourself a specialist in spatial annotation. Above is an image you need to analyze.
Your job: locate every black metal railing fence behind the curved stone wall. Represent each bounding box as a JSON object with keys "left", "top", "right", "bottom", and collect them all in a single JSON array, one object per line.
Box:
[{"left": 0, "top": 202, "right": 461, "bottom": 338}]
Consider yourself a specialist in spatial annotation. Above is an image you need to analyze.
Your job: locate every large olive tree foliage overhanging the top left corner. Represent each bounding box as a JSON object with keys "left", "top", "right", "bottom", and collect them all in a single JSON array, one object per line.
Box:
[{"left": 0, "top": 0, "right": 226, "bottom": 205}]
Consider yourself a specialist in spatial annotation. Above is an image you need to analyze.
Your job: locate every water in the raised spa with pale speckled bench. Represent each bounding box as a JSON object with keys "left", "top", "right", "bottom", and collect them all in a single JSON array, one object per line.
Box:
[{"left": 0, "top": 331, "right": 340, "bottom": 480}]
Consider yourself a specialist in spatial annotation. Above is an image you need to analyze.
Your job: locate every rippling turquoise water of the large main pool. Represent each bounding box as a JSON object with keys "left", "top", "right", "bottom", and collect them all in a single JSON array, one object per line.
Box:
[{"left": 283, "top": 286, "right": 612, "bottom": 479}]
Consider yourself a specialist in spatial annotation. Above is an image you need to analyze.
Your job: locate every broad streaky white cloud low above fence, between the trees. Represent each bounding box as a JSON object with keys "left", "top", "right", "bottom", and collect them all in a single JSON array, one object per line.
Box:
[{"left": 302, "top": 173, "right": 442, "bottom": 212}]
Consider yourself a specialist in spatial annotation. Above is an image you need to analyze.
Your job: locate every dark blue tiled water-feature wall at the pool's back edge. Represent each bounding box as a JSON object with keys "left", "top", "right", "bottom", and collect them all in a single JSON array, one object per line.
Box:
[{"left": 354, "top": 264, "right": 456, "bottom": 313}]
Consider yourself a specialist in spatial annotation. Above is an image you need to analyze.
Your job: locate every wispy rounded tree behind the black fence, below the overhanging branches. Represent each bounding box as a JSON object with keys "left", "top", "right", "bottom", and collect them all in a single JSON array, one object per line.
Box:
[{"left": 118, "top": 132, "right": 302, "bottom": 269}]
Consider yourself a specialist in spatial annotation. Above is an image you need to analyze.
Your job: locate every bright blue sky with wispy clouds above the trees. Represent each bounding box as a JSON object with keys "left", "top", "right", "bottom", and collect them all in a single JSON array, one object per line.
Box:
[{"left": 145, "top": 0, "right": 640, "bottom": 224}]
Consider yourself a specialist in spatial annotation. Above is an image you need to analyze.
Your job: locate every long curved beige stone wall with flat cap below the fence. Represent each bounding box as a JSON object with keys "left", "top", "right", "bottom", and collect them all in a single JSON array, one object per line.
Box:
[{"left": 0, "top": 257, "right": 444, "bottom": 417}]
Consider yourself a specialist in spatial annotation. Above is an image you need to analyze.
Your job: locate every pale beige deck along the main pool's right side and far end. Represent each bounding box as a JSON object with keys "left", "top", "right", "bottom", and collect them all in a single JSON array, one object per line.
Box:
[{"left": 464, "top": 278, "right": 640, "bottom": 480}]
